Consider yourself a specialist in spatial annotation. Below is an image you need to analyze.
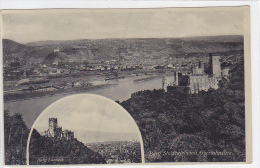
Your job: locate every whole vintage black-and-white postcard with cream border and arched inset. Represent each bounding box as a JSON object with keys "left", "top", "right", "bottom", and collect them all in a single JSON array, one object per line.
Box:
[{"left": 1, "top": 6, "right": 252, "bottom": 165}]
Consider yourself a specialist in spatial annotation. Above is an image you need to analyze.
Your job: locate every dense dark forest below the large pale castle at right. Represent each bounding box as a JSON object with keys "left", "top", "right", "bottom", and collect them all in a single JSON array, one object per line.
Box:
[{"left": 120, "top": 62, "right": 245, "bottom": 162}]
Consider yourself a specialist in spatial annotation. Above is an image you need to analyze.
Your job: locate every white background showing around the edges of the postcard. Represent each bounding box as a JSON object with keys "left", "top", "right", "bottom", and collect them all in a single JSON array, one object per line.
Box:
[{"left": 0, "top": 0, "right": 260, "bottom": 168}]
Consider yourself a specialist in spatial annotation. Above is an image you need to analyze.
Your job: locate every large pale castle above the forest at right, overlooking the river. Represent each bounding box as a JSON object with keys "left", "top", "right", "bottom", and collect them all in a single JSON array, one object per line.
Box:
[{"left": 163, "top": 53, "right": 229, "bottom": 94}]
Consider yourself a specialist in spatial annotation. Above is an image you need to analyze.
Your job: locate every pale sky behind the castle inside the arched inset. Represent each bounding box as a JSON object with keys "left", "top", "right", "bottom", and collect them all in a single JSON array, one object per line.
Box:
[{"left": 34, "top": 94, "right": 142, "bottom": 142}]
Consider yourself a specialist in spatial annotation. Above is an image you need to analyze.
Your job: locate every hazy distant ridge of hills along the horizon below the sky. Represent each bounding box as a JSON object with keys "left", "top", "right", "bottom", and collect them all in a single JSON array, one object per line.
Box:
[{"left": 3, "top": 36, "right": 244, "bottom": 64}]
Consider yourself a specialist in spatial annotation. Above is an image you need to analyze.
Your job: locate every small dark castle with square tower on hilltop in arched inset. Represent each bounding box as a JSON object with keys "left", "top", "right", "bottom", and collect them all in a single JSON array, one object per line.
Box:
[{"left": 41, "top": 118, "right": 74, "bottom": 140}]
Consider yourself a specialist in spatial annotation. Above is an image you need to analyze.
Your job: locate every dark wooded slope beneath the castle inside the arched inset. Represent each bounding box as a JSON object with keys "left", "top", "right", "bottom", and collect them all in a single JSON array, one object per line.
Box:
[{"left": 29, "top": 129, "right": 106, "bottom": 165}]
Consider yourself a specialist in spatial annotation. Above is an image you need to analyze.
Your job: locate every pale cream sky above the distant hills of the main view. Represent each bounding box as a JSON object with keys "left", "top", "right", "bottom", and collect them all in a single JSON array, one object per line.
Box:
[{"left": 3, "top": 7, "right": 247, "bottom": 43}]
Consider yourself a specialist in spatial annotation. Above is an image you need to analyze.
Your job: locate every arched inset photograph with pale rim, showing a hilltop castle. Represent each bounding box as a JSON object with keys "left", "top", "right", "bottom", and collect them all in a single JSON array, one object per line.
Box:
[{"left": 27, "top": 94, "right": 144, "bottom": 165}]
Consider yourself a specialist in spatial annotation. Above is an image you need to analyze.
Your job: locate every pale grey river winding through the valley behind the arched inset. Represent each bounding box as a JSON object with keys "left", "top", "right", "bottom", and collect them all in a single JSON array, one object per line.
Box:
[{"left": 4, "top": 76, "right": 162, "bottom": 128}]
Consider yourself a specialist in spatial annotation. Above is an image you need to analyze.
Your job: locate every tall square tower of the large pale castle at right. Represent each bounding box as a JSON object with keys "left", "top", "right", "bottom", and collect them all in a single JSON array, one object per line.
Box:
[{"left": 209, "top": 53, "right": 221, "bottom": 77}]
